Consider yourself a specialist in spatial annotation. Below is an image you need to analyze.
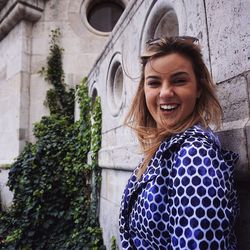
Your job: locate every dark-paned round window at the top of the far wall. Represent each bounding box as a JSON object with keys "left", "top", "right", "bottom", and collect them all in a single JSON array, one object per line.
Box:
[{"left": 87, "top": 1, "right": 124, "bottom": 32}]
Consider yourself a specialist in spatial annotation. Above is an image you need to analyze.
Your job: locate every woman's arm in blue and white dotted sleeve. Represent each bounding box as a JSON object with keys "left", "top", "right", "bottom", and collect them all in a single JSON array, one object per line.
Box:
[{"left": 168, "top": 142, "right": 235, "bottom": 249}]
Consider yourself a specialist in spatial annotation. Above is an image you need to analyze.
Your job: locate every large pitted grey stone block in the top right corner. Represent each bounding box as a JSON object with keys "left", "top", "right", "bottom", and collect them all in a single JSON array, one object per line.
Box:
[{"left": 206, "top": 0, "right": 250, "bottom": 82}]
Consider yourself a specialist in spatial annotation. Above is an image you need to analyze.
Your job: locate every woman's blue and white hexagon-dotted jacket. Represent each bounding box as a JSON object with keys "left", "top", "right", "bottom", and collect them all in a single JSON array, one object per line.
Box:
[{"left": 119, "top": 125, "right": 239, "bottom": 250}]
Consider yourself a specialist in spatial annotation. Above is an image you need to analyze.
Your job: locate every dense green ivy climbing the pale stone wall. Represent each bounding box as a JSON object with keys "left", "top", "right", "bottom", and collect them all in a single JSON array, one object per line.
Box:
[{"left": 0, "top": 30, "right": 105, "bottom": 250}]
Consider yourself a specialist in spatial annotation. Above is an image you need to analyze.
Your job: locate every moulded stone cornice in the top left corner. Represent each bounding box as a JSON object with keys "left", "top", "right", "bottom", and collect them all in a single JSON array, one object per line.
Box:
[{"left": 0, "top": 0, "right": 46, "bottom": 41}]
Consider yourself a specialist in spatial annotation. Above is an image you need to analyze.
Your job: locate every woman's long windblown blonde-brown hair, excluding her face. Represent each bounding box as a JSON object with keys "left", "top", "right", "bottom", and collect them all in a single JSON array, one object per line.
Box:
[{"left": 125, "top": 37, "right": 222, "bottom": 178}]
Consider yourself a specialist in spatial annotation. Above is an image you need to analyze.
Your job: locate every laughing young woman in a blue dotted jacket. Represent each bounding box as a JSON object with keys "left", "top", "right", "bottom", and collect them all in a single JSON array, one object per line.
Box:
[{"left": 119, "top": 37, "right": 238, "bottom": 250}]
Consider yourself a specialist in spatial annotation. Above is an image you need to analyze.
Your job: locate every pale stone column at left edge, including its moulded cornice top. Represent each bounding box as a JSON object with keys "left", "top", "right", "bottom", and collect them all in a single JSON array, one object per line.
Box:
[{"left": 0, "top": 0, "right": 44, "bottom": 167}]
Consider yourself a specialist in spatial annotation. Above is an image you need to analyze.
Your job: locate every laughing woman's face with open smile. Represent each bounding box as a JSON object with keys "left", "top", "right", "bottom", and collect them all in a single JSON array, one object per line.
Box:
[{"left": 144, "top": 53, "right": 200, "bottom": 128}]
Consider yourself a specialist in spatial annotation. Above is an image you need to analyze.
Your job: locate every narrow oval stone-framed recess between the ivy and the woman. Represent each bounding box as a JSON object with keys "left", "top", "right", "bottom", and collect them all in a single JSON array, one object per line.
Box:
[{"left": 107, "top": 54, "right": 124, "bottom": 116}]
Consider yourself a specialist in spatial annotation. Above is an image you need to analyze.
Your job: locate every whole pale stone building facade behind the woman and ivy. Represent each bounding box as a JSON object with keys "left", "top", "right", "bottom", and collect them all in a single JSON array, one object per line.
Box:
[{"left": 0, "top": 0, "right": 250, "bottom": 249}]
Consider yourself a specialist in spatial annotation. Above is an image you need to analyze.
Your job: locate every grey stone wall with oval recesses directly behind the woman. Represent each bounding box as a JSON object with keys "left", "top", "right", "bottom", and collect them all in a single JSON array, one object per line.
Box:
[{"left": 86, "top": 0, "right": 250, "bottom": 249}]
